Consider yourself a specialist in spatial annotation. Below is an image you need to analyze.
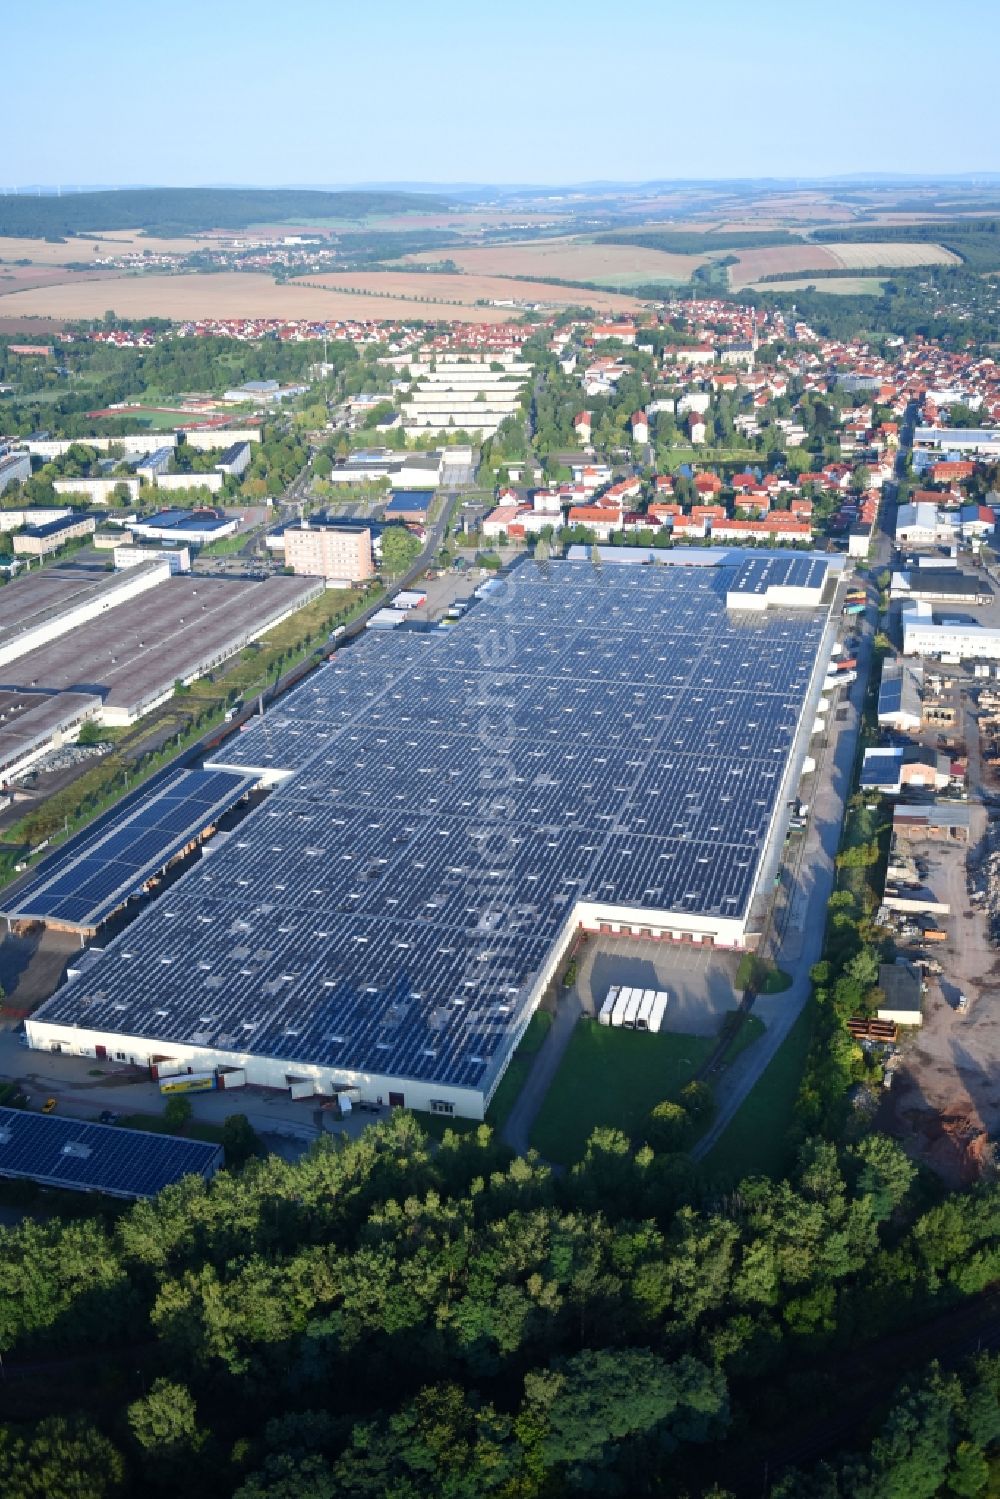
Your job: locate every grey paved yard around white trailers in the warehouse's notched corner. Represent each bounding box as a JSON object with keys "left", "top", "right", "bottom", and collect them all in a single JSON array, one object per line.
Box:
[{"left": 576, "top": 937, "right": 739, "bottom": 1036}]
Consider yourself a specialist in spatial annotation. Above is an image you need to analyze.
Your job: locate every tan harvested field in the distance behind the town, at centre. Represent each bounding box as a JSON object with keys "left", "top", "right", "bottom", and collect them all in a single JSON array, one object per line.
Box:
[{"left": 406, "top": 238, "right": 708, "bottom": 286}]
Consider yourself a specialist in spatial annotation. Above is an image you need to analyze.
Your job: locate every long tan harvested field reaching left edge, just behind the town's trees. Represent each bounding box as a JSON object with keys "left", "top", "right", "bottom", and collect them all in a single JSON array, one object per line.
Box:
[{"left": 0, "top": 271, "right": 560, "bottom": 323}]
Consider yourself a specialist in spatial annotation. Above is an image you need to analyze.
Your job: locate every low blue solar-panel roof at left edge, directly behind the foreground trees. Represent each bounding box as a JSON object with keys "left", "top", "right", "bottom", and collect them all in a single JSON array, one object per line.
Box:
[{"left": 0, "top": 1108, "right": 222, "bottom": 1198}]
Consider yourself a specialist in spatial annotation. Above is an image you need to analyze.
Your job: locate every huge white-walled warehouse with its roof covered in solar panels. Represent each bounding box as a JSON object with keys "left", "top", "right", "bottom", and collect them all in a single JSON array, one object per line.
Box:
[{"left": 25, "top": 556, "right": 834, "bottom": 1118}]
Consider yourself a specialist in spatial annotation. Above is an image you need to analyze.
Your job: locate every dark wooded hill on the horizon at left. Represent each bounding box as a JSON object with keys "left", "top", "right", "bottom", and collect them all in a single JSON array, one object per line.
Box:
[{"left": 0, "top": 187, "right": 448, "bottom": 240}]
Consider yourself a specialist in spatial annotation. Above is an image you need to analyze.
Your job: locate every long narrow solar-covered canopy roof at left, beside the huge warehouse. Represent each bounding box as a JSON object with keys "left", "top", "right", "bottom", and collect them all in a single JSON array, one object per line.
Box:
[{"left": 3, "top": 770, "right": 253, "bottom": 931}]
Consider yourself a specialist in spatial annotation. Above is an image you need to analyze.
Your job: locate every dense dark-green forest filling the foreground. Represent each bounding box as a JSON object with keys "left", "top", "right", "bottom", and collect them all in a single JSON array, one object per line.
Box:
[{"left": 0, "top": 1112, "right": 1000, "bottom": 1499}]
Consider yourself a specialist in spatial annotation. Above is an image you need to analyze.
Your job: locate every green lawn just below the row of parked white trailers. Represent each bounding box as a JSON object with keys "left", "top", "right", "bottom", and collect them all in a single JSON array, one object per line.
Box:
[{"left": 531, "top": 1019, "right": 715, "bottom": 1165}]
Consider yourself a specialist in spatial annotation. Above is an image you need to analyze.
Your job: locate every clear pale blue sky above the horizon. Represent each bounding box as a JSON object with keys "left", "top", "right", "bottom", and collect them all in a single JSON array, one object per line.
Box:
[{"left": 7, "top": 0, "right": 1000, "bottom": 186}]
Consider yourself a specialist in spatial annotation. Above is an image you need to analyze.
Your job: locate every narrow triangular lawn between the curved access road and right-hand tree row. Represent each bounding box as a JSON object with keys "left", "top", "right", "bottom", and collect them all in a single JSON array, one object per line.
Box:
[{"left": 703, "top": 1006, "right": 813, "bottom": 1183}]
